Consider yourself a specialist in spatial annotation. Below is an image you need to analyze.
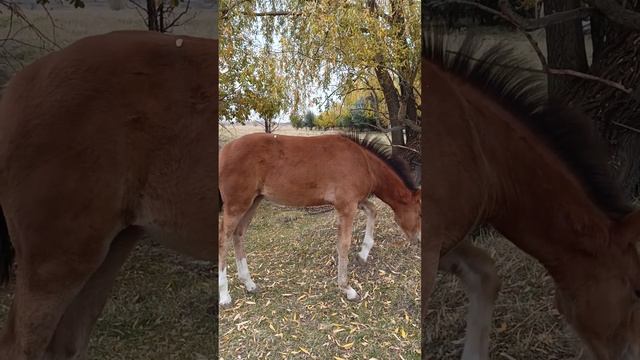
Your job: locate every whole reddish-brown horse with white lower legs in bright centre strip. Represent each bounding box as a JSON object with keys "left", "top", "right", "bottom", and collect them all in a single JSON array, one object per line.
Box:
[{"left": 218, "top": 134, "right": 421, "bottom": 306}]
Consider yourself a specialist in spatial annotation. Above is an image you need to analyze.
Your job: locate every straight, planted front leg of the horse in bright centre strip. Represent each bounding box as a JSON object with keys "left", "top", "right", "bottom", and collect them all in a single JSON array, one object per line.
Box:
[{"left": 336, "top": 204, "right": 360, "bottom": 301}]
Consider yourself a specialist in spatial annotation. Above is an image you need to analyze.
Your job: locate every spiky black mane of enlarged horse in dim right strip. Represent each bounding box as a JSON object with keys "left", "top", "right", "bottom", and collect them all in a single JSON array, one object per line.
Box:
[{"left": 422, "top": 27, "right": 632, "bottom": 218}]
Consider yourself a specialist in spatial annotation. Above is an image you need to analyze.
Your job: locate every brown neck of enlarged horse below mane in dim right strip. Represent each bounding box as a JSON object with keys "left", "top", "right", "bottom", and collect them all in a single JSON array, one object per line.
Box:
[{"left": 458, "top": 82, "right": 611, "bottom": 273}]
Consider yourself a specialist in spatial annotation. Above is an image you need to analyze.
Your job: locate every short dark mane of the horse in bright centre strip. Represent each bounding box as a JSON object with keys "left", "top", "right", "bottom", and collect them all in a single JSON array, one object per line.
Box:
[{"left": 340, "top": 132, "right": 418, "bottom": 191}]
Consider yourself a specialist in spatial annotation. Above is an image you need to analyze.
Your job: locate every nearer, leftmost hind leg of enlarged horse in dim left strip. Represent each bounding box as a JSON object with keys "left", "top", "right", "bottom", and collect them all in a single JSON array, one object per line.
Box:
[{"left": 0, "top": 231, "right": 114, "bottom": 360}]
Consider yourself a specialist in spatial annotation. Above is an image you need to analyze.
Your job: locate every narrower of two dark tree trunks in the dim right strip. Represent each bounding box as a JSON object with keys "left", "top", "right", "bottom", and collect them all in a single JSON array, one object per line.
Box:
[{"left": 544, "top": 0, "right": 589, "bottom": 98}]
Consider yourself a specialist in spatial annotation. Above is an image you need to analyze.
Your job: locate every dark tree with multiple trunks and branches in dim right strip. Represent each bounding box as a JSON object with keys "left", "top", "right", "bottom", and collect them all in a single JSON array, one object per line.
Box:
[{"left": 425, "top": 0, "right": 640, "bottom": 196}]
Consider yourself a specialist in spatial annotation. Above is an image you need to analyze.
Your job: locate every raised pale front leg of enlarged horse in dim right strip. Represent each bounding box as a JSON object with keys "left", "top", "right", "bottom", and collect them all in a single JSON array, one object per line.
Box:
[{"left": 440, "top": 240, "right": 500, "bottom": 360}]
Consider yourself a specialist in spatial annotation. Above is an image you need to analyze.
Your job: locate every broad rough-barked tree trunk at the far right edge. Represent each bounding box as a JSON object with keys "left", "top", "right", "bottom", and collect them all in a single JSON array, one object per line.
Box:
[{"left": 568, "top": 1, "right": 640, "bottom": 198}]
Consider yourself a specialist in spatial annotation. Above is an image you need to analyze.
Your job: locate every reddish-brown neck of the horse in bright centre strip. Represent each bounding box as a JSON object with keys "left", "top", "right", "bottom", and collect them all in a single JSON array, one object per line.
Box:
[{"left": 367, "top": 154, "right": 411, "bottom": 210}]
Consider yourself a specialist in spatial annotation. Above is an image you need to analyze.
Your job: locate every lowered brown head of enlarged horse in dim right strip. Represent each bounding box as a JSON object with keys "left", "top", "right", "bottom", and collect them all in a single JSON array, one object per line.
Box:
[{"left": 556, "top": 213, "right": 640, "bottom": 360}]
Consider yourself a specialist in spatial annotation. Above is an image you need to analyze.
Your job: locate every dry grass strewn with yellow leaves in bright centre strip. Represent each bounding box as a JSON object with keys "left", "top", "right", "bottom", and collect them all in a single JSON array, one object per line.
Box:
[{"left": 219, "top": 126, "right": 420, "bottom": 360}]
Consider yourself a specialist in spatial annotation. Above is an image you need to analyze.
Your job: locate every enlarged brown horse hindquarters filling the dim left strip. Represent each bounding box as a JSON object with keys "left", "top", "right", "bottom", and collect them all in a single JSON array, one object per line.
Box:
[{"left": 0, "top": 32, "right": 218, "bottom": 360}]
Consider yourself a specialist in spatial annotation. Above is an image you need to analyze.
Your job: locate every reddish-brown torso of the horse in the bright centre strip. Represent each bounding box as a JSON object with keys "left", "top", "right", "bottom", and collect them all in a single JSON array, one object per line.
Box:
[{"left": 219, "top": 134, "right": 370, "bottom": 206}]
